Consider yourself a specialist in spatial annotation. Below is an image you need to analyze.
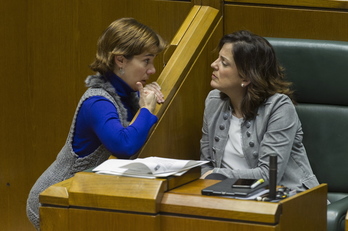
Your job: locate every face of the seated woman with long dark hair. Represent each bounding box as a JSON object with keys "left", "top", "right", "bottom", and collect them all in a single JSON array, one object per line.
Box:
[{"left": 210, "top": 43, "right": 243, "bottom": 94}]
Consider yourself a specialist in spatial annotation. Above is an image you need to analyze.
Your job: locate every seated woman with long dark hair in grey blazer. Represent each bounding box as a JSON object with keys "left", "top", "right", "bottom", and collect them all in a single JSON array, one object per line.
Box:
[{"left": 201, "top": 31, "right": 319, "bottom": 191}]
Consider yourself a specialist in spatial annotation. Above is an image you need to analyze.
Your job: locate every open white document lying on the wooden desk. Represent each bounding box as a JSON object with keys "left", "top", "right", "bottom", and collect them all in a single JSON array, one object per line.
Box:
[{"left": 93, "top": 157, "right": 208, "bottom": 178}]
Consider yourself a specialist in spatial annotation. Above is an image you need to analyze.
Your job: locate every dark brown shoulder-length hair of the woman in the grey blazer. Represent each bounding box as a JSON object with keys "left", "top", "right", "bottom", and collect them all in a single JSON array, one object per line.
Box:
[{"left": 219, "top": 30, "right": 293, "bottom": 120}]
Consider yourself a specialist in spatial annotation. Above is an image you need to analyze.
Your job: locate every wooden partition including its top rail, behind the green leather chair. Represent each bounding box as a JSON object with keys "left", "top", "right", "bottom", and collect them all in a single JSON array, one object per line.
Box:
[{"left": 224, "top": 0, "right": 348, "bottom": 41}]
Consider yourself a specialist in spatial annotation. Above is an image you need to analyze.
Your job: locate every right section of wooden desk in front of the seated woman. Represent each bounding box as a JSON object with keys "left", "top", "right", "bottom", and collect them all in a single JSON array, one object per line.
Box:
[{"left": 160, "top": 180, "right": 327, "bottom": 231}]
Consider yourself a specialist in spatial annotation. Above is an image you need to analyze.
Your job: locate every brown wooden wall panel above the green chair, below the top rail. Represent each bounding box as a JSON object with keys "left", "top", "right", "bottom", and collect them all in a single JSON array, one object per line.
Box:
[{"left": 224, "top": 4, "right": 348, "bottom": 41}]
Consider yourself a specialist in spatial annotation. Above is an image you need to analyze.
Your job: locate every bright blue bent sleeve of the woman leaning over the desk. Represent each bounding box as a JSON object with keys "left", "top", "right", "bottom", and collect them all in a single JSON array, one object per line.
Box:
[{"left": 76, "top": 97, "right": 157, "bottom": 158}]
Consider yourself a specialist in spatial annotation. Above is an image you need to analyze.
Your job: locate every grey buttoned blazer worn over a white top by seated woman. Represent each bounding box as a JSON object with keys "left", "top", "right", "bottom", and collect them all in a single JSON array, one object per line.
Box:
[{"left": 201, "top": 90, "right": 319, "bottom": 191}]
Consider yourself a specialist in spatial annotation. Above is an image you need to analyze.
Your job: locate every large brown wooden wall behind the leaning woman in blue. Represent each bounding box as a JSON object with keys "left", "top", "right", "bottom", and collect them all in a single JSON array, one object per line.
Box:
[{"left": 0, "top": 0, "right": 192, "bottom": 231}]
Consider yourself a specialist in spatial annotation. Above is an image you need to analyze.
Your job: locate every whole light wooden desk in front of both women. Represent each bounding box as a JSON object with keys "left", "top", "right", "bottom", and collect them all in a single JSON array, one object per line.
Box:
[{"left": 40, "top": 173, "right": 327, "bottom": 231}]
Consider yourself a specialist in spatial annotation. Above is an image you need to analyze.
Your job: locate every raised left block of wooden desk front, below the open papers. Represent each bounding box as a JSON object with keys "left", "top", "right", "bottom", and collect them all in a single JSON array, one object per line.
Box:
[{"left": 69, "top": 172, "right": 168, "bottom": 213}]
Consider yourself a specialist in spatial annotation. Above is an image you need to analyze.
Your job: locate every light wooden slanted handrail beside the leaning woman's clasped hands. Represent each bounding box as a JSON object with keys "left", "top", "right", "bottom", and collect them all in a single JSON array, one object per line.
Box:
[{"left": 154, "top": 6, "right": 219, "bottom": 117}]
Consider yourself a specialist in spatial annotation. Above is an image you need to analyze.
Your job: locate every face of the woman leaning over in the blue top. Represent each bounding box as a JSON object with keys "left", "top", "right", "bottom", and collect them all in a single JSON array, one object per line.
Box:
[{"left": 115, "top": 52, "right": 156, "bottom": 91}]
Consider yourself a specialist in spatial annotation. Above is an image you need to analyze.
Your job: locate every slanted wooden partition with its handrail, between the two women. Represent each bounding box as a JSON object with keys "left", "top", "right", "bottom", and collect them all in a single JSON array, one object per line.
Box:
[{"left": 139, "top": 6, "right": 222, "bottom": 159}]
